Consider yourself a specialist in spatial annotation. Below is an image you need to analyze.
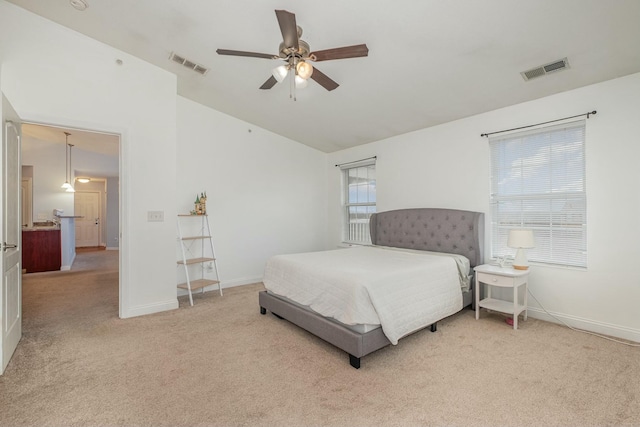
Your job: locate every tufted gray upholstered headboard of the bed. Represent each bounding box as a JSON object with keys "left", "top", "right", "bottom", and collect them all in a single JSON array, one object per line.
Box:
[{"left": 369, "top": 208, "right": 484, "bottom": 267}]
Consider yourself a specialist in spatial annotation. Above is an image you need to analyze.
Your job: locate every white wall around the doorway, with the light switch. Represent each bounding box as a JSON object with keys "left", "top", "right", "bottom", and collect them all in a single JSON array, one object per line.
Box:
[{"left": 0, "top": 0, "right": 177, "bottom": 317}]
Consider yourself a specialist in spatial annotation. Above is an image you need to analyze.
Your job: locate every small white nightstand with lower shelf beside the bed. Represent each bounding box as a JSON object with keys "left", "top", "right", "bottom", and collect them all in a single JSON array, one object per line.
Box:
[{"left": 474, "top": 264, "right": 529, "bottom": 329}]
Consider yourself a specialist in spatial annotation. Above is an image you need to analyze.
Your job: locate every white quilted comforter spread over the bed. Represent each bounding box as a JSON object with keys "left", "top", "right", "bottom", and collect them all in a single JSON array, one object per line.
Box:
[{"left": 264, "top": 246, "right": 469, "bottom": 344}]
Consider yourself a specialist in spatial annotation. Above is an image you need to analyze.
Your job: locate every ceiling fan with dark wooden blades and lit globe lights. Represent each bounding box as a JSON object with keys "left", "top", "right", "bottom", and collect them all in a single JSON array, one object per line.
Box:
[{"left": 216, "top": 10, "right": 369, "bottom": 90}]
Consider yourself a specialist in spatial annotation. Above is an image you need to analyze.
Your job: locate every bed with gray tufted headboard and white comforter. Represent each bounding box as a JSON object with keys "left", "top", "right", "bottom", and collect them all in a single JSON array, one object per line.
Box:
[{"left": 258, "top": 208, "right": 484, "bottom": 369}]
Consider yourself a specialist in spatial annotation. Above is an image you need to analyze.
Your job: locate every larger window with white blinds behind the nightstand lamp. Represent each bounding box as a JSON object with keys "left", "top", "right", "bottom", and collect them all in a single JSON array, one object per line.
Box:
[{"left": 489, "top": 120, "right": 587, "bottom": 267}]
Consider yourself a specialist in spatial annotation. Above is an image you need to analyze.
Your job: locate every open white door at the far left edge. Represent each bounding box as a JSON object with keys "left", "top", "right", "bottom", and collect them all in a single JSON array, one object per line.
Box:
[{"left": 0, "top": 95, "right": 22, "bottom": 374}]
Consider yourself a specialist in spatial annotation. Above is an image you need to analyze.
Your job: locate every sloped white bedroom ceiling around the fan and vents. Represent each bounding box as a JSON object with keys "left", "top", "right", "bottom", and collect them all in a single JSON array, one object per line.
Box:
[{"left": 9, "top": 0, "right": 640, "bottom": 152}]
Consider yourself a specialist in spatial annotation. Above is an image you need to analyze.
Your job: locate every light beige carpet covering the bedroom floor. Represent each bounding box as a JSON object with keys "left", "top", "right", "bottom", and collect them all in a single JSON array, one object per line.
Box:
[{"left": 0, "top": 251, "right": 640, "bottom": 426}]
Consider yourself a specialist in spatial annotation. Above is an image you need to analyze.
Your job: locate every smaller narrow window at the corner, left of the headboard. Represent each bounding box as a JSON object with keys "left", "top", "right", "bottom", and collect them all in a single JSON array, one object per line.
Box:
[{"left": 342, "top": 160, "right": 376, "bottom": 244}]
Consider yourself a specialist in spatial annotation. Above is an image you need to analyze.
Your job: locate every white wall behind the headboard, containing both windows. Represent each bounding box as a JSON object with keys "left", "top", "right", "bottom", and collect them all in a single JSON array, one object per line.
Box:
[{"left": 327, "top": 74, "right": 640, "bottom": 341}]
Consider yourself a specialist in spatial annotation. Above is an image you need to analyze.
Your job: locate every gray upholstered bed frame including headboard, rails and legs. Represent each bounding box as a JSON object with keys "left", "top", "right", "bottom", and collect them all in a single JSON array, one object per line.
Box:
[{"left": 258, "top": 208, "right": 484, "bottom": 369}]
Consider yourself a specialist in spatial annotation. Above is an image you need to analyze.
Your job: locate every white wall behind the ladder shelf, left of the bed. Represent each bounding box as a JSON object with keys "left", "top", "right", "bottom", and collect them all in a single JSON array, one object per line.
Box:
[{"left": 176, "top": 97, "right": 327, "bottom": 287}]
